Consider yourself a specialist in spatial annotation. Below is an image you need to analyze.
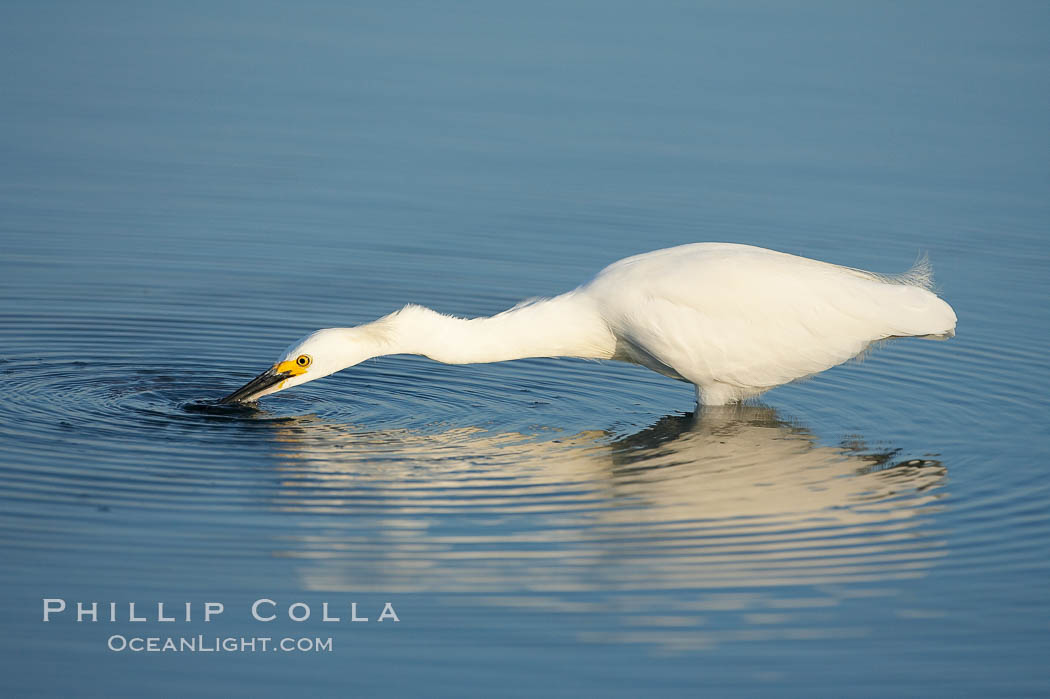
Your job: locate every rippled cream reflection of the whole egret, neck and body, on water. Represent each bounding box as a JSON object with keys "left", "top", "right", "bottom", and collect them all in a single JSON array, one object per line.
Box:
[{"left": 258, "top": 406, "right": 946, "bottom": 600}]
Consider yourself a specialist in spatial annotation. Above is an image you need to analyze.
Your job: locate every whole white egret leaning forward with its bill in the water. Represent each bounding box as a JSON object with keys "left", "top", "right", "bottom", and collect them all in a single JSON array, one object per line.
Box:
[{"left": 221, "top": 242, "right": 956, "bottom": 405}]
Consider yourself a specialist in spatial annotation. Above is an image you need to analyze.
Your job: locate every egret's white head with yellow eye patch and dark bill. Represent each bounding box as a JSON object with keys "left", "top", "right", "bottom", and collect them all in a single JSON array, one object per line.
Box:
[{"left": 219, "top": 327, "right": 372, "bottom": 403}]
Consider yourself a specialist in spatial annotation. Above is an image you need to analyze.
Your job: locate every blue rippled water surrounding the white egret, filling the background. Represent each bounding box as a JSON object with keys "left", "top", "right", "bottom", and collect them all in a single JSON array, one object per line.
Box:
[{"left": 0, "top": 2, "right": 1050, "bottom": 697}]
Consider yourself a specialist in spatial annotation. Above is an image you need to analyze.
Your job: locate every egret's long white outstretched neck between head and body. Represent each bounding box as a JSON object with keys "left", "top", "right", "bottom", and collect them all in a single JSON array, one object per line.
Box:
[{"left": 359, "top": 292, "right": 615, "bottom": 364}]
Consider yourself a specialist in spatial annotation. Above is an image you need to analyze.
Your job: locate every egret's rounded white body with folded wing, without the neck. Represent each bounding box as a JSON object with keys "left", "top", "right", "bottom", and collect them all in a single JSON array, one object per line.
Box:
[{"left": 586, "top": 243, "right": 954, "bottom": 394}]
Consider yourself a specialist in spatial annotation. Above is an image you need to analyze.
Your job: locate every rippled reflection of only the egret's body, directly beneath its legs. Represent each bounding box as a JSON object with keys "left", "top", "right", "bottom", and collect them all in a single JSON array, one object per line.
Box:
[{"left": 608, "top": 406, "right": 946, "bottom": 525}]
